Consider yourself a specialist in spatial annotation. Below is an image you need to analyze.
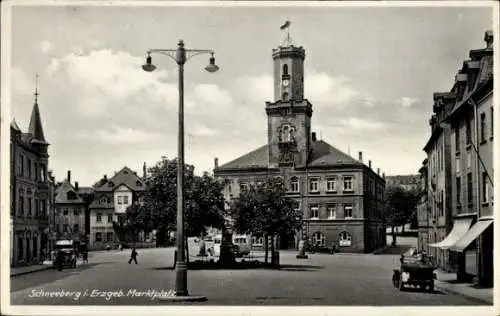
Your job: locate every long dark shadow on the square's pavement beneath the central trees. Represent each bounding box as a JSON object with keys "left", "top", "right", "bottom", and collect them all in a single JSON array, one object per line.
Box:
[{"left": 152, "top": 262, "right": 324, "bottom": 272}]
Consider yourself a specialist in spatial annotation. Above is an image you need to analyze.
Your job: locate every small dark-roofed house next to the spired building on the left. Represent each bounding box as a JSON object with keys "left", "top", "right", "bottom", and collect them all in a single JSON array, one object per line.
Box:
[{"left": 54, "top": 171, "right": 85, "bottom": 244}]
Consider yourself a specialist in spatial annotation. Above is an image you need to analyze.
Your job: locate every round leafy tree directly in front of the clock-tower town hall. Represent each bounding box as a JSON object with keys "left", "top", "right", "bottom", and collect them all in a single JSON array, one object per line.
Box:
[{"left": 229, "top": 178, "right": 302, "bottom": 264}]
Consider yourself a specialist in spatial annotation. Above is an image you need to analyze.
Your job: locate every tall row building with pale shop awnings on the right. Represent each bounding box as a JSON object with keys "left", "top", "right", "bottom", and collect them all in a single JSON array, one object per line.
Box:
[{"left": 433, "top": 31, "right": 494, "bottom": 285}]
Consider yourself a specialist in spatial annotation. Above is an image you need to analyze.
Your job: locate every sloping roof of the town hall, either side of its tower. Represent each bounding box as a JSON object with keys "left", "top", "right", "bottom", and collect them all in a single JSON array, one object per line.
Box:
[{"left": 217, "top": 140, "right": 363, "bottom": 171}]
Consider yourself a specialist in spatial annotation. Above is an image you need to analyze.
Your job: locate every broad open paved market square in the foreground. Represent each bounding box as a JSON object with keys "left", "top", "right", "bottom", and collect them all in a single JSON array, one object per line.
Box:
[{"left": 11, "top": 248, "right": 477, "bottom": 306}]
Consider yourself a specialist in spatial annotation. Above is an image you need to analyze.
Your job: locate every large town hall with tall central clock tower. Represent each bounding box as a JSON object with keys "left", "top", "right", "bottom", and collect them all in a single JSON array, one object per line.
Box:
[{"left": 214, "top": 39, "right": 386, "bottom": 252}]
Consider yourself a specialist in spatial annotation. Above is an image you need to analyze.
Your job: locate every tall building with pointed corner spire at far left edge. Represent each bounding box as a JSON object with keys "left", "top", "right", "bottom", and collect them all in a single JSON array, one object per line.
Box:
[{"left": 10, "top": 94, "right": 50, "bottom": 266}]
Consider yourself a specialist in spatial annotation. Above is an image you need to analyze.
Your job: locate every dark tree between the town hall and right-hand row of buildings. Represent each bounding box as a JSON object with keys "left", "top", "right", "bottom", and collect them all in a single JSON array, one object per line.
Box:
[{"left": 384, "top": 186, "right": 418, "bottom": 246}]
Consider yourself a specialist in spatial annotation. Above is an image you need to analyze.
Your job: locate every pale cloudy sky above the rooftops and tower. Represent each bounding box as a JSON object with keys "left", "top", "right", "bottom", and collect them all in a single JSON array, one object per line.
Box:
[{"left": 5, "top": 3, "right": 493, "bottom": 186}]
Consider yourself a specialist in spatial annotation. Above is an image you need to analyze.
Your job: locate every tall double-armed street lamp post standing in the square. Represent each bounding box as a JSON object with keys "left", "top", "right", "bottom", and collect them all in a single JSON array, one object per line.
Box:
[{"left": 142, "top": 40, "right": 219, "bottom": 297}]
